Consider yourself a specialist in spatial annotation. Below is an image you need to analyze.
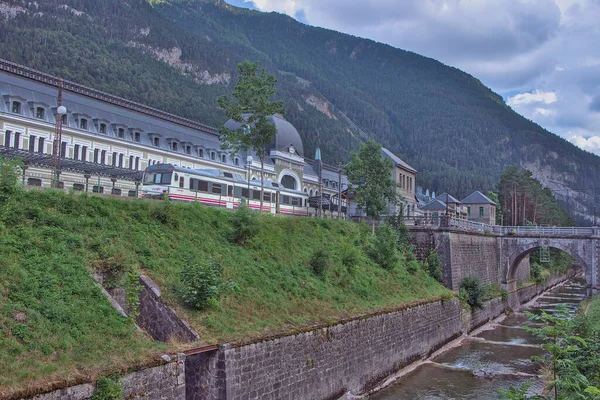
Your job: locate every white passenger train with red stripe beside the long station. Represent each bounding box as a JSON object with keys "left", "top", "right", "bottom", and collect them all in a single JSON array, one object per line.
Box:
[{"left": 141, "top": 164, "right": 309, "bottom": 216}]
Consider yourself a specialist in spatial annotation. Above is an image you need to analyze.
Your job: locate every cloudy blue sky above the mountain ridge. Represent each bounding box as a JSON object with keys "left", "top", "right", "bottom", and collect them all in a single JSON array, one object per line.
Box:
[{"left": 227, "top": 0, "right": 600, "bottom": 155}]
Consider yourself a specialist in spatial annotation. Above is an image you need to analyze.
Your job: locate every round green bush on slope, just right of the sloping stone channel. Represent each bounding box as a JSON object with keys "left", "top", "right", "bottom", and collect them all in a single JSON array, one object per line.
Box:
[{"left": 180, "top": 260, "right": 226, "bottom": 309}]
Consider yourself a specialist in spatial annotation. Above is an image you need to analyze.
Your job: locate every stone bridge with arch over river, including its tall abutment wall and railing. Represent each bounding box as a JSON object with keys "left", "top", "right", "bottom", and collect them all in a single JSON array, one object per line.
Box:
[{"left": 407, "top": 217, "right": 600, "bottom": 294}]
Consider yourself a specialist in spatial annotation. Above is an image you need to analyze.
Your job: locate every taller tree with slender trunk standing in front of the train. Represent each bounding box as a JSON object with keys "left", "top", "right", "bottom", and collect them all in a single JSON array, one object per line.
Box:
[{"left": 217, "top": 60, "right": 285, "bottom": 214}]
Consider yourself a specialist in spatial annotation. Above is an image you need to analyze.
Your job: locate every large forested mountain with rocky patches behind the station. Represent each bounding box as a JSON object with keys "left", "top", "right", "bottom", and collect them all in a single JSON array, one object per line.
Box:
[{"left": 0, "top": 0, "right": 600, "bottom": 223}]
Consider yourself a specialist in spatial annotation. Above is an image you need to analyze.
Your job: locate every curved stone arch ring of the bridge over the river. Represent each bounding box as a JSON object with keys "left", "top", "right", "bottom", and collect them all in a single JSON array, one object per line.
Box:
[{"left": 504, "top": 239, "right": 590, "bottom": 282}]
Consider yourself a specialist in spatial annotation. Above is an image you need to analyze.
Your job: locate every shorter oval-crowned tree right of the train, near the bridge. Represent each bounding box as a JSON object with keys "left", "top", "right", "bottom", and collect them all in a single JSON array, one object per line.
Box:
[{"left": 346, "top": 139, "right": 402, "bottom": 235}]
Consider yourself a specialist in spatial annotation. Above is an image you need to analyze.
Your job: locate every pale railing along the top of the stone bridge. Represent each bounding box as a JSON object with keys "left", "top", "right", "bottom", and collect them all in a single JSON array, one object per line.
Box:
[{"left": 402, "top": 216, "right": 600, "bottom": 236}]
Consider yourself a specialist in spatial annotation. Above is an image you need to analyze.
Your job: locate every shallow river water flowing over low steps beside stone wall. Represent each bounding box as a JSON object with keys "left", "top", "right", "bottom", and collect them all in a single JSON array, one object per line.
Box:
[{"left": 369, "top": 279, "right": 587, "bottom": 400}]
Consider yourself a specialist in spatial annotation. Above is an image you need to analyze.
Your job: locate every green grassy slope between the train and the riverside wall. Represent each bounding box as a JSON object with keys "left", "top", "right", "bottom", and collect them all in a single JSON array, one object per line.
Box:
[{"left": 0, "top": 191, "right": 447, "bottom": 393}]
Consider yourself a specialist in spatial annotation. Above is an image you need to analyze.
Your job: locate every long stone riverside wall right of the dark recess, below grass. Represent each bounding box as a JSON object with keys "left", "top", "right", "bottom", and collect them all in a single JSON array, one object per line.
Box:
[{"left": 222, "top": 300, "right": 461, "bottom": 400}]
